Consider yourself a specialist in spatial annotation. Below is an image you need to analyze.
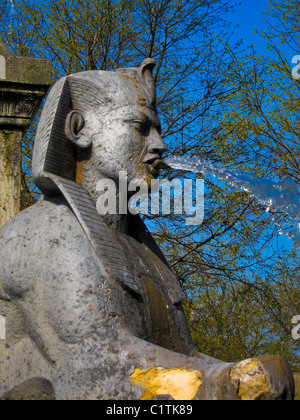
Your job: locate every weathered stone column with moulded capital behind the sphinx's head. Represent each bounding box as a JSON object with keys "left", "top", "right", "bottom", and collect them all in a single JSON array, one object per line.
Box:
[{"left": 0, "top": 38, "right": 51, "bottom": 228}]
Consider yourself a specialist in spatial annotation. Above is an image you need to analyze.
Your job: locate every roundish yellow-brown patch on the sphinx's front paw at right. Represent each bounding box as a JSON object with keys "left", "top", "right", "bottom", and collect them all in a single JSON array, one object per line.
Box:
[{"left": 230, "top": 359, "right": 270, "bottom": 401}]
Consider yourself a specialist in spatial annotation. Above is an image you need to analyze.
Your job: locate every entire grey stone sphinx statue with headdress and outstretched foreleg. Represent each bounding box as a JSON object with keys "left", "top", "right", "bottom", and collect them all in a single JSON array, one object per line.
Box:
[{"left": 0, "top": 59, "right": 294, "bottom": 400}]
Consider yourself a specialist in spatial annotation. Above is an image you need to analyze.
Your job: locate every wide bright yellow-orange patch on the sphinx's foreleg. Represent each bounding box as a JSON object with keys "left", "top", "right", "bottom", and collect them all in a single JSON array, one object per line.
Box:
[{"left": 131, "top": 367, "right": 202, "bottom": 400}]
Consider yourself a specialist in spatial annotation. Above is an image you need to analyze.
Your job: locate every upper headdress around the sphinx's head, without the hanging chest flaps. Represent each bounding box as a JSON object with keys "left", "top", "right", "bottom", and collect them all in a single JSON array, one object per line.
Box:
[{"left": 32, "top": 59, "right": 156, "bottom": 195}]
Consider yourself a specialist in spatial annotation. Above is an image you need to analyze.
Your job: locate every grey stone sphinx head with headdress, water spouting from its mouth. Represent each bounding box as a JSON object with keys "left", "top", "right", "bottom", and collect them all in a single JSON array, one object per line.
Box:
[{"left": 32, "top": 59, "right": 166, "bottom": 195}]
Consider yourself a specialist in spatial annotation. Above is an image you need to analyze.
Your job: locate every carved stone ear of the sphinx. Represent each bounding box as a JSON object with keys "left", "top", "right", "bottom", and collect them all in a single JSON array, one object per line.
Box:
[{"left": 65, "top": 111, "right": 92, "bottom": 150}]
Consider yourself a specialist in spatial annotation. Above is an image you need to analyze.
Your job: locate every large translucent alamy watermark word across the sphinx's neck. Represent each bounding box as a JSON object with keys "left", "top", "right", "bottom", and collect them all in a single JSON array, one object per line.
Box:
[{"left": 96, "top": 171, "right": 204, "bottom": 226}]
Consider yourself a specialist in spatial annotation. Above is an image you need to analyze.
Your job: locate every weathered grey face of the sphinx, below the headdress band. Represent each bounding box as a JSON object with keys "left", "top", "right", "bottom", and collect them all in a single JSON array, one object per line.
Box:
[{"left": 92, "top": 105, "right": 167, "bottom": 185}]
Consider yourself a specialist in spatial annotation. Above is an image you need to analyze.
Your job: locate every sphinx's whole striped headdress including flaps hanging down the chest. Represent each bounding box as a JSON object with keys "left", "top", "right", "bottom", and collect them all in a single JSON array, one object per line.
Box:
[{"left": 32, "top": 59, "right": 176, "bottom": 302}]
